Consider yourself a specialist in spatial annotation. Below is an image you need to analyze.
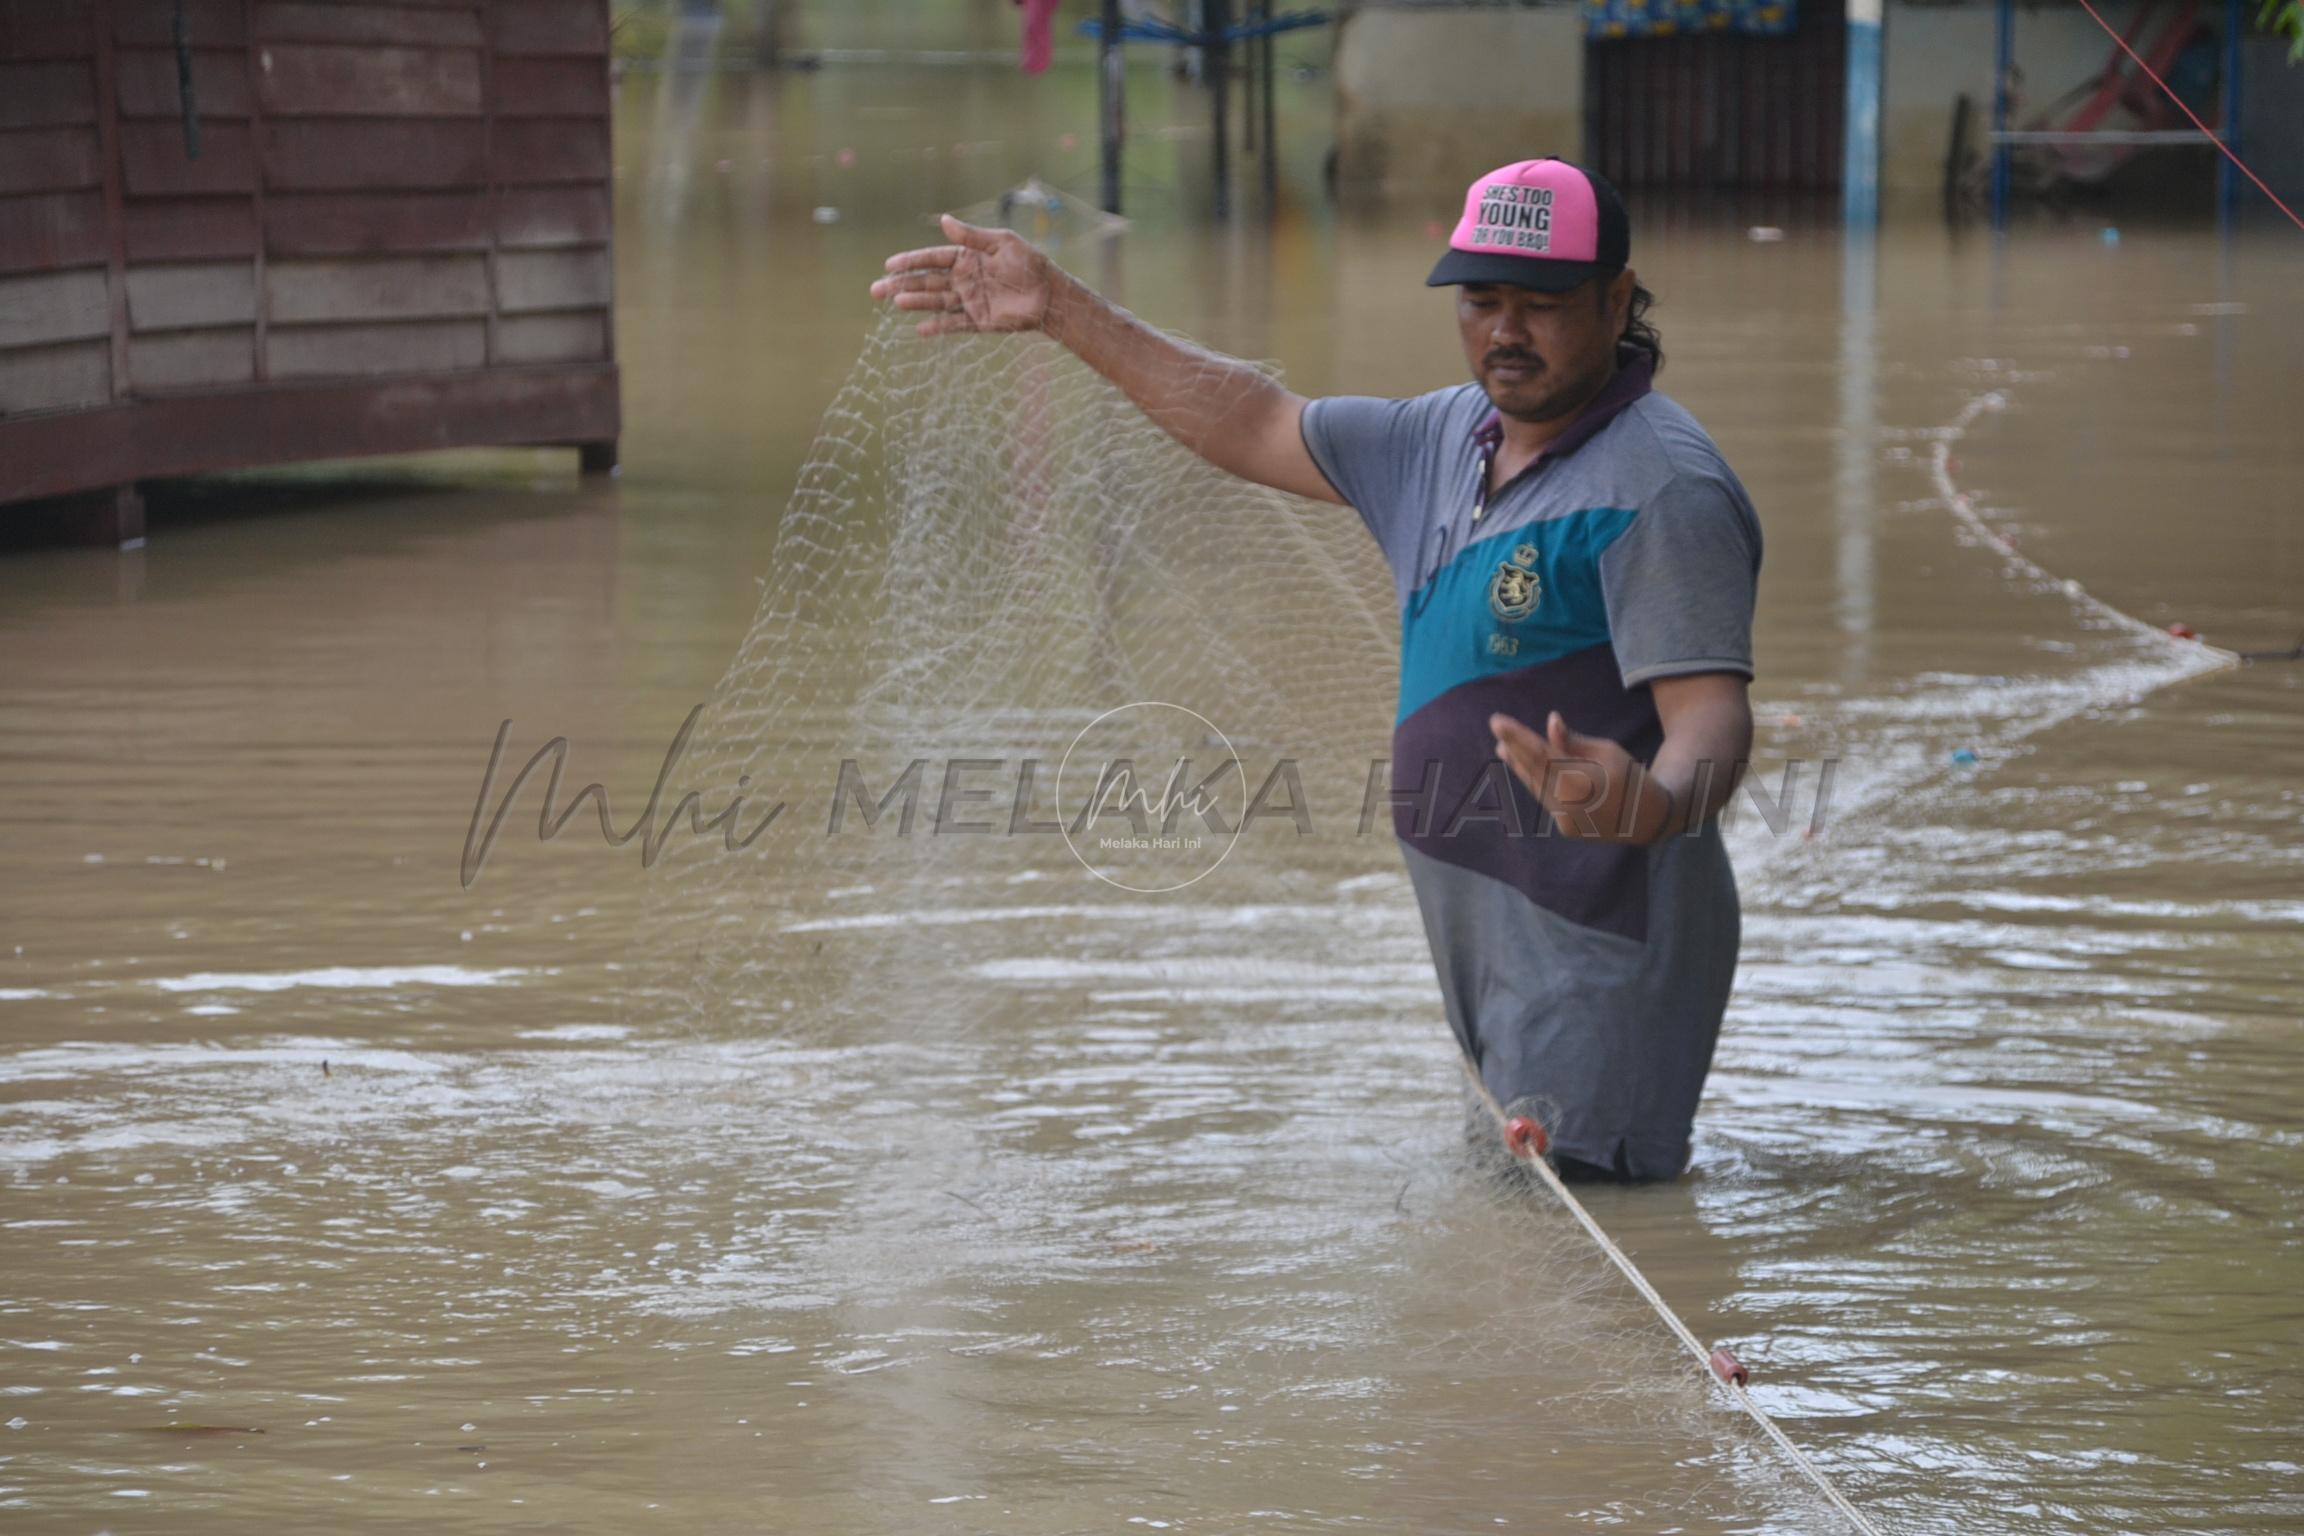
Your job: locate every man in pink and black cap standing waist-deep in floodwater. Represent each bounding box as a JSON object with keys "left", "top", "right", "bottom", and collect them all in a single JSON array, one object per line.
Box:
[{"left": 871, "top": 159, "right": 1760, "bottom": 1179}]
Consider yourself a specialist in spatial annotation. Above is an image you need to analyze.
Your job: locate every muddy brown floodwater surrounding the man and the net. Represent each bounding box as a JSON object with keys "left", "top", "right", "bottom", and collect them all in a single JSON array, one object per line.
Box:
[{"left": 0, "top": 67, "right": 2304, "bottom": 1536}]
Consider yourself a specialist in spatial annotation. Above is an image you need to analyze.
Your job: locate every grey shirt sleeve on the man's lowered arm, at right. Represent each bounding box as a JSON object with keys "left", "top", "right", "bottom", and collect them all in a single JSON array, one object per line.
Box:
[{"left": 1599, "top": 474, "right": 1760, "bottom": 689}]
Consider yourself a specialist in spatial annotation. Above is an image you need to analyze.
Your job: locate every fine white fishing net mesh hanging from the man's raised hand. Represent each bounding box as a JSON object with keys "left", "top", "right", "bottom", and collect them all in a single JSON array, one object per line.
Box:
[{"left": 645, "top": 320, "right": 1415, "bottom": 1039}]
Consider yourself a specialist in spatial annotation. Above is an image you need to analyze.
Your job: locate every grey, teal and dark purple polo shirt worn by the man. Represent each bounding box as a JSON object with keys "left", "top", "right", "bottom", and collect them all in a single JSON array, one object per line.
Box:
[{"left": 1304, "top": 352, "right": 1760, "bottom": 1177}]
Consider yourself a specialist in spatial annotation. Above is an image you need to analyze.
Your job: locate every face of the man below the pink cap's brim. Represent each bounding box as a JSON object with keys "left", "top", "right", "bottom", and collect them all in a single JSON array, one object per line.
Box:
[{"left": 1456, "top": 269, "right": 1634, "bottom": 421}]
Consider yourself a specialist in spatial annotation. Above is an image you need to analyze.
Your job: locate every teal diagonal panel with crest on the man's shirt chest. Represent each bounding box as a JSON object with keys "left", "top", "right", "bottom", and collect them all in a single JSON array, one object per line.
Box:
[{"left": 1394, "top": 507, "right": 1636, "bottom": 725}]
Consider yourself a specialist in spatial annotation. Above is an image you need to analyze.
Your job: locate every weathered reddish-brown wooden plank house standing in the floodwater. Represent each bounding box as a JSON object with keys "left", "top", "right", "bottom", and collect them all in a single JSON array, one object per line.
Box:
[{"left": 0, "top": 0, "right": 617, "bottom": 539}]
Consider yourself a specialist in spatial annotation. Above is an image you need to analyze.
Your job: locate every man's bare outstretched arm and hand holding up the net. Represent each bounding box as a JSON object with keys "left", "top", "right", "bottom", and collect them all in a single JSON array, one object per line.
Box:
[{"left": 871, "top": 214, "right": 1343, "bottom": 502}]
